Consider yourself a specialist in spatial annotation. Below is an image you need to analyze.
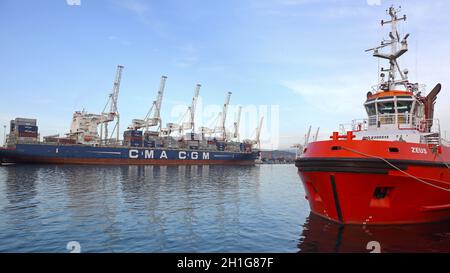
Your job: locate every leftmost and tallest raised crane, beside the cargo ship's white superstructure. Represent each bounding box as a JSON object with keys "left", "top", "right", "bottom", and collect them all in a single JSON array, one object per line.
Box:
[{"left": 100, "top": 65, "right": 124, "bottom": 142}]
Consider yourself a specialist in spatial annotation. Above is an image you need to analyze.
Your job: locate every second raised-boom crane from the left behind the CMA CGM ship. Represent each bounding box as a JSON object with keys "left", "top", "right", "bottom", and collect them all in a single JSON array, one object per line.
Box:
[{"left": 128, "top": 76, "right": 167, "bottom": 131}]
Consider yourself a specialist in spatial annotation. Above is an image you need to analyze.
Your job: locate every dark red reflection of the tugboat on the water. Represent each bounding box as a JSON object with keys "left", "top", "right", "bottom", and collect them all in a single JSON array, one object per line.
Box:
[{"left": 298, "top": 213, "right": 450, "bottom": 253}]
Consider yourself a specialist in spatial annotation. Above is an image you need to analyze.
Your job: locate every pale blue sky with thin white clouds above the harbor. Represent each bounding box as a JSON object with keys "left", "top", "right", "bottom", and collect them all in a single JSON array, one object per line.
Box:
[{"left": 0, "top": 0, "right": 450, "bottom": 148}]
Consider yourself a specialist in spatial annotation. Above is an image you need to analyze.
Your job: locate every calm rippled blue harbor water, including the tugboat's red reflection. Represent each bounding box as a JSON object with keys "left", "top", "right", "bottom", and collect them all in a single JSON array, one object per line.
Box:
[{"left": 0, "top": 165, "right": 450, "bottom": 252}]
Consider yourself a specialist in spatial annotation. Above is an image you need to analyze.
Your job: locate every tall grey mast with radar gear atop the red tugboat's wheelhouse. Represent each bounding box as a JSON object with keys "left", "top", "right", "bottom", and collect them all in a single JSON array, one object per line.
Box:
[{"left": 366, "top": 6, "right": 409, "bottom": 91}]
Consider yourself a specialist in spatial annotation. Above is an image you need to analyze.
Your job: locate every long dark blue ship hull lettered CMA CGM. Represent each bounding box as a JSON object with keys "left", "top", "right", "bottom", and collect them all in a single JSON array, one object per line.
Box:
[{"left": 0, "top": 144, "right": 257, "bottom": 165}]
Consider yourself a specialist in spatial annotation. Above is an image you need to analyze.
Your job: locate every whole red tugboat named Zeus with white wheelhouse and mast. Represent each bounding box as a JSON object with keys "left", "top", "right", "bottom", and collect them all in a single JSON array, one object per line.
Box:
[{"left": 295, "top": 7, "right": 450, "bottom": 224}]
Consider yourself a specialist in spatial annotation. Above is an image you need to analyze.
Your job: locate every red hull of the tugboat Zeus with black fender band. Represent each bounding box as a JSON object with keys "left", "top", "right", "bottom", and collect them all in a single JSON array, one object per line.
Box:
[{"left": 296, "top": 140, "right": 450, "bottom": 224}]
